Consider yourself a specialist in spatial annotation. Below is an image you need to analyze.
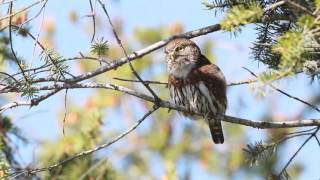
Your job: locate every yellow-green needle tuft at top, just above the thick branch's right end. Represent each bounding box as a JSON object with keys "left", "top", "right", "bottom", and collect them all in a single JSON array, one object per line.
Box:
[{"left": 221, "top": 4, "right": 263, "bottom": 32}]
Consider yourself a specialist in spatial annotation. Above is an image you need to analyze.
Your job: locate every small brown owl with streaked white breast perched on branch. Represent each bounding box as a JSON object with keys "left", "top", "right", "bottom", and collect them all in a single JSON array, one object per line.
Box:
[{"left": 165, "top": 38, "right": 227, "bottom": 144}]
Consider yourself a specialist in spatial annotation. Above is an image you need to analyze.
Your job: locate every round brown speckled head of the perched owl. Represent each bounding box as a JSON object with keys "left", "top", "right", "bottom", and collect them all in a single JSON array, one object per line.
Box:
[{"left": 164, "top": 38, "right": 201, "bottom": 77}]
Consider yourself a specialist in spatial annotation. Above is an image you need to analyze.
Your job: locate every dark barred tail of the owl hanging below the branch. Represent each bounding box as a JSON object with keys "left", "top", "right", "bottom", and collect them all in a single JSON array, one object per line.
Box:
[{"left": 207, "top": 118, "right": 224, "bottom": 144}]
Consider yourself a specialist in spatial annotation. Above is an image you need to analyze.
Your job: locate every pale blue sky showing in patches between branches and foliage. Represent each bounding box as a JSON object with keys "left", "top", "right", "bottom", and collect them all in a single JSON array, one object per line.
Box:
[{"left": 1, "top": 0, "right": 320, "bottom": 179}]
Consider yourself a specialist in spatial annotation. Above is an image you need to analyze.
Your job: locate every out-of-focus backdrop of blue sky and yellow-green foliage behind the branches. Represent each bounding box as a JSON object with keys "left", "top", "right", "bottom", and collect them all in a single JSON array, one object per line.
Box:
[{"left": 0, "top": 0, "right": 320, "bottom": 179}]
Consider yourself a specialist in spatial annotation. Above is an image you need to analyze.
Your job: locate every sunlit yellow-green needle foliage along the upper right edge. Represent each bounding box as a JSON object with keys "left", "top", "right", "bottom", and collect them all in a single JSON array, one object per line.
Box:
[{"left": 259, "top": 15, "right": 319, "bottom": 83}]
